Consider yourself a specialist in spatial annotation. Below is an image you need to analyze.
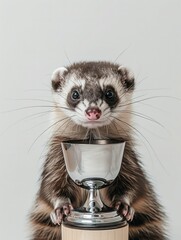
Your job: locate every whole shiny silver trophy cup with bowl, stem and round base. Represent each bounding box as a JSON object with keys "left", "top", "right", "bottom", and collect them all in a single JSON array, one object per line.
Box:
[{"left": 61, "top": 140, "right": 126, "bottom": 229}]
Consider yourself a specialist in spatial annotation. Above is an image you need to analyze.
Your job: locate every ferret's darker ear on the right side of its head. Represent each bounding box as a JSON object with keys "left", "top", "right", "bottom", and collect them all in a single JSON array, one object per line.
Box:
[{"left": 118, "top": 66, "right": 135, "bottom": 91}]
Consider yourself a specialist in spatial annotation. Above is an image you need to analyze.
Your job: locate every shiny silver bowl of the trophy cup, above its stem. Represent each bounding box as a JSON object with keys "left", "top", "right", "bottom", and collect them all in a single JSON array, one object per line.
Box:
[{"left": 62, "top": 140, "right": 125, "bottom": 187}]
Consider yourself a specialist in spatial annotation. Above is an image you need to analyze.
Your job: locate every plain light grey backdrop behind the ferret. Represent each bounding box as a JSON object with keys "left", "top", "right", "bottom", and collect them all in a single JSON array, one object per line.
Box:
[{"left": 0, "top": 0, "right": 181, "bottom": 240}]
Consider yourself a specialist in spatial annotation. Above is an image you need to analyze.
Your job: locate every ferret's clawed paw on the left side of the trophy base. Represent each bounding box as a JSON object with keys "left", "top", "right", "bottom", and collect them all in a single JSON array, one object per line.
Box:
[{"left": 50, "top": 199, "right": 73, "bottom": 225}]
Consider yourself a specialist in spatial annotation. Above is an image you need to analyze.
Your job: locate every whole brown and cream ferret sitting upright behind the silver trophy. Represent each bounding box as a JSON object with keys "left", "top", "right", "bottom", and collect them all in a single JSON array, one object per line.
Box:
[{"left": 29, "top": 61, "right": 167, "bottom": 240}]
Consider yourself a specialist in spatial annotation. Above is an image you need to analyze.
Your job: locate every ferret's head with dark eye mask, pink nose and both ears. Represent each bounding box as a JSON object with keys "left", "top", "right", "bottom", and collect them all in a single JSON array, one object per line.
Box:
[{"left": 52, "top": 62, "right": 134, "bottom": 129}]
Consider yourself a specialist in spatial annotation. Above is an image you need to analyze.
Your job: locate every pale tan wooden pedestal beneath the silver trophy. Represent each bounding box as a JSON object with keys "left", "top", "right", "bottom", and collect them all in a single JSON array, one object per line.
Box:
[{"left": 62, "top": 224, "right": 128, "bottom": 240}]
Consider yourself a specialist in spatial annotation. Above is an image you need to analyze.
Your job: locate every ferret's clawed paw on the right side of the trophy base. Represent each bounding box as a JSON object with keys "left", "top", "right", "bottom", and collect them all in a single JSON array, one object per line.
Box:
[{"left": 114, "top": 200, "right": 135, "bottom": 222}]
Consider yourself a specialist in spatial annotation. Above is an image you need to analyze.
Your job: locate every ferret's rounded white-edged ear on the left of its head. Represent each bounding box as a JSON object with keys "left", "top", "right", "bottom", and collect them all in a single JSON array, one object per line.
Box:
[{"left": 51, "top": 67, "right": 68, "bottom": 91}]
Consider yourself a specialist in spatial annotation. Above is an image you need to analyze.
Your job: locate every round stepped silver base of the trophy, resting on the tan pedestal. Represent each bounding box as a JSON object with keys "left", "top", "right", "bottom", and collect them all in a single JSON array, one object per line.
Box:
[{"left": 64, "top": 210, "right": 127, "bottom": 229}]
